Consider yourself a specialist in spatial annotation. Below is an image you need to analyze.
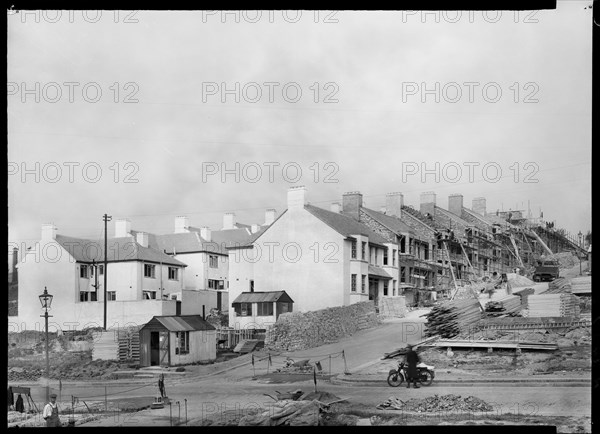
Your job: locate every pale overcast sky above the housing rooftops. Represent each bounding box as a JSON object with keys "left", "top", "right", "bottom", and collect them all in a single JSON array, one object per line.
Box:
[{"left": 8, "top": 1, "right": 592, "bottom": 254}]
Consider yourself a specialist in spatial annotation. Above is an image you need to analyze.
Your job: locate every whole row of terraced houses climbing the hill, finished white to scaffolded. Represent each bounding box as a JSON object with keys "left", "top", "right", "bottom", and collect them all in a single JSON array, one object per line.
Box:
[{"left": 10, "top": 186, "right": 581, "bottom": 330}]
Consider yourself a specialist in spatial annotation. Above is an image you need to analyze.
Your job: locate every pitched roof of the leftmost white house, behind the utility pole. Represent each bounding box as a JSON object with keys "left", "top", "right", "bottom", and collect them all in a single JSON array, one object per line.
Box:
[{"left": 56, "top": 235, "right": 187, "bottom": 267}]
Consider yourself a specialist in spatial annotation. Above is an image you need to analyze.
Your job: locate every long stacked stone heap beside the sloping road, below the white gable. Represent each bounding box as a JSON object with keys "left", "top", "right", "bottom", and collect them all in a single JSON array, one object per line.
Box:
[{"left": 265, "top": 301, "right": 379, "bottom": 351}]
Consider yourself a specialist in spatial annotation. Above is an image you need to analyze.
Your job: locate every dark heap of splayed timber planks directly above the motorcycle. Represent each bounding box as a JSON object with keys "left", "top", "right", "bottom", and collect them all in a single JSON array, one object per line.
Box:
[{"left": 425, "top": 299, "right": 481, "bottom": 338}]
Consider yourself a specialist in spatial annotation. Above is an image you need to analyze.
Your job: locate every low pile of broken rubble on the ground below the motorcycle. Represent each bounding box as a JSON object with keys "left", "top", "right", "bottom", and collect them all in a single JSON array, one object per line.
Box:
[{"left": 377, "top": 394, "right": 493, "bottom": 413}]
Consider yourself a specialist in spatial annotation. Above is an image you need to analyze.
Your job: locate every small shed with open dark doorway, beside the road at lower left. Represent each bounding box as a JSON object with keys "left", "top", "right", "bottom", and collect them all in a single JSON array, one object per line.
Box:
[{"left": 140, "top": 315, "right": 217, "bottom": 366}]
